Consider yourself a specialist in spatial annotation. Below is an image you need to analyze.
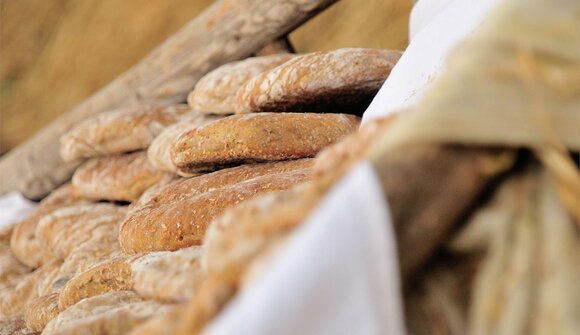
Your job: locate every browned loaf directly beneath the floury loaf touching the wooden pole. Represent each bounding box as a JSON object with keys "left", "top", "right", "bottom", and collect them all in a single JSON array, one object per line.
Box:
[{"left": 72, "top": 151, "right": 172, "bottom": 201}]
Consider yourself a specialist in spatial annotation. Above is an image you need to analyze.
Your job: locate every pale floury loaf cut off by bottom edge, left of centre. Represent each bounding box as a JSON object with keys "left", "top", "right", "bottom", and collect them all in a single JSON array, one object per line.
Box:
[{"left": 42, "top": 291, "right": 166, "bottom": 335}]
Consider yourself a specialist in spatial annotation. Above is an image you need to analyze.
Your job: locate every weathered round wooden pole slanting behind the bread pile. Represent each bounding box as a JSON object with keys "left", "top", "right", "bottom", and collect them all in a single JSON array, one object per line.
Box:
[{"left": 0, "top": 0, "right": 336, "bottom": 198}]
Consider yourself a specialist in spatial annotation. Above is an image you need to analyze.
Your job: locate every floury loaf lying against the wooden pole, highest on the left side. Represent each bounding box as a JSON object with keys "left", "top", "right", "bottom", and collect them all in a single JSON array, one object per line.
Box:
[{"left": 60, "top": 105, "right": 192, "bottom": 161}]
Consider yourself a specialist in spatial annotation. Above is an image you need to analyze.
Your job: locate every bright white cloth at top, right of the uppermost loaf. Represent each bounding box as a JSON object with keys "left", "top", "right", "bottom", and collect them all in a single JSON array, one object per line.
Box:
[{"left": 363, "top": 0, "right": 501, "bottom": 123}]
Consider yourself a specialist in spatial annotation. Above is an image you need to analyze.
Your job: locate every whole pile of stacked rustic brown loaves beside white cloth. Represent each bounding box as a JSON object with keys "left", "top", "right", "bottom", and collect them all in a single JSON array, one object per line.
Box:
[{"left": 0, "top": 49, "right": 400, "bottom": 335}]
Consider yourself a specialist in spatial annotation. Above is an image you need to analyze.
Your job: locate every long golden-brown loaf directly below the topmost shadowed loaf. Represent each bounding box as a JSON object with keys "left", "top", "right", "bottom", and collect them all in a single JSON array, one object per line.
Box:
[{"left": 171, "top": 113, "right": 359, "bottom": 173}]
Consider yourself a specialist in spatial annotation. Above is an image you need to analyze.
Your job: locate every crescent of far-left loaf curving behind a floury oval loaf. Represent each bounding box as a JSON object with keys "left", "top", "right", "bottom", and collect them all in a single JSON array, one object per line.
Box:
[{"left": 10, "top": 183, "right": 90, "bottom": 268}]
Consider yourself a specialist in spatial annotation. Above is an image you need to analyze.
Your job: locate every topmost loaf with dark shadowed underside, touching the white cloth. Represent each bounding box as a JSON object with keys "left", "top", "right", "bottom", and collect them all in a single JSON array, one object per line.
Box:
[{"left": 236, "top": 48, "right": 401, "bottom": 115}]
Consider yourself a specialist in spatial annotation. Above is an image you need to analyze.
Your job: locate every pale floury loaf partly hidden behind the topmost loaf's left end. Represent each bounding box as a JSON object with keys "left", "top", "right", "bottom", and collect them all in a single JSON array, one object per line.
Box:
[{"left": 187, "top": 54, "right": 296, "bottom": 114}]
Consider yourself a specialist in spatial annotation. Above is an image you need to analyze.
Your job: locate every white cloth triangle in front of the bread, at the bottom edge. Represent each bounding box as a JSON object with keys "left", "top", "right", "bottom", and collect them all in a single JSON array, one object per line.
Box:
[{"left": 205, "top": 163, "right": 405, "bottom": 335}]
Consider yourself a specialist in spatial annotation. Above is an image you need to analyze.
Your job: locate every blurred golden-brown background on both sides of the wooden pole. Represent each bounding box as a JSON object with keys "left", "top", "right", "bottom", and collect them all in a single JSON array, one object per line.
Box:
[{"left": 0, "top": 0, "right": 412, "bottom": 154}]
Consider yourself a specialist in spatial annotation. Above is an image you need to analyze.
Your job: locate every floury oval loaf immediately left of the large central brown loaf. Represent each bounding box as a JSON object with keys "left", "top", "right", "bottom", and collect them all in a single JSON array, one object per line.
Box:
[{"left": 36, "top": 203, "right": 126, "bottom": 259}]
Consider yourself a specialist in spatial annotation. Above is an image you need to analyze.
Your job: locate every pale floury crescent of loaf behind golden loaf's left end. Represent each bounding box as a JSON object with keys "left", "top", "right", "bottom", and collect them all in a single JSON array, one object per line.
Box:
[{"left": 147, "top": 113, "right": 220, "bottom": 176}]
